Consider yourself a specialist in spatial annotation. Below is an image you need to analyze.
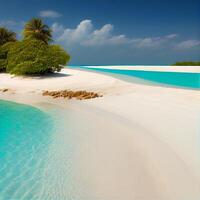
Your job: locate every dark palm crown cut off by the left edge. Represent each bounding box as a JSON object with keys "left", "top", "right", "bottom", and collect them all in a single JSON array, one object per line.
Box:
[{"left": 0, "top": 27, "right": 17, "bottom": 46}]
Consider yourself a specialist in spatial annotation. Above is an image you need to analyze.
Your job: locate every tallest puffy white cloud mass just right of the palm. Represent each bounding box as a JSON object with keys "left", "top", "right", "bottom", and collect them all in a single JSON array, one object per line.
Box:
[{"left": 52, "top": 19, "right": 129, "bottom": 46}]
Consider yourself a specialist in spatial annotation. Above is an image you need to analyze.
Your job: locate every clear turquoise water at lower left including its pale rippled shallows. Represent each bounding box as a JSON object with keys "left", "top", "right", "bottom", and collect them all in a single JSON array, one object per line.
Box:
[{"left": 0, "top": 100, "right": 89, "bottom": 200}]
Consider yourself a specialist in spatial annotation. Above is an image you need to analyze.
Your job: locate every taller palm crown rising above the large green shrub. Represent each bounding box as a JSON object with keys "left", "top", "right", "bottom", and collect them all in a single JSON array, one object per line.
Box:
[{"left": 23, "top": 18, "right": 52, "bottom": 44}]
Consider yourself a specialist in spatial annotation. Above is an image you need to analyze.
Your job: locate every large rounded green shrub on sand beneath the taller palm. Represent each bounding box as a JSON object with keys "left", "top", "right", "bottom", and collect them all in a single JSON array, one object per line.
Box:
[{"left": 6, "top": 39, "right": 70, "bottom": 75}]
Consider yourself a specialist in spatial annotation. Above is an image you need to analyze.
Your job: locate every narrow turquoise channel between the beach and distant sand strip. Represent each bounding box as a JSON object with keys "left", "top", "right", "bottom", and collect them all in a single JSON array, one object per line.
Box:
[{"left": 72, "top": 66, "right": 200, "bottom": 89}]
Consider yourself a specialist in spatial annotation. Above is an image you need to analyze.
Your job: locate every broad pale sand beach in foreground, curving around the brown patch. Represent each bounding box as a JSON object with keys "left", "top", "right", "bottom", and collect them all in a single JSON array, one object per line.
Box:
[{"left": 0, "top": 67, "right": 200, "bottom": 200}]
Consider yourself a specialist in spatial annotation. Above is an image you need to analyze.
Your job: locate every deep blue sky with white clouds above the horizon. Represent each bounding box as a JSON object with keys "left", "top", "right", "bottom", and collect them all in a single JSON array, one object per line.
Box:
[{"left": 0, "top": 0, "right": 200, "bottom": 65}]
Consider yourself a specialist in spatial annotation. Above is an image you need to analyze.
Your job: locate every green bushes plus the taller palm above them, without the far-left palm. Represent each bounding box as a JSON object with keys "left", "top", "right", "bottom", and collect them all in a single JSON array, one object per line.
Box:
[{"left": 0, "top": 18, "right": 70, "bottom": 75}]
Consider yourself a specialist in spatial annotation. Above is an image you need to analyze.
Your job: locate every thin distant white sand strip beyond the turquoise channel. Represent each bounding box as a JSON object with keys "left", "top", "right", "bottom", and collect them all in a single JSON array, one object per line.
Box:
[{"left": 84, "top": 65, "right": 200, "bottom": 73}]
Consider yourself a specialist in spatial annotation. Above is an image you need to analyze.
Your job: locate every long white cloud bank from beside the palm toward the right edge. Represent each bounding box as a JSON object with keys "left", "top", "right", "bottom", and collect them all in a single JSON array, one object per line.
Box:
[{"left": 52, "top": 19, "right": 188, "bottom": 48}]
